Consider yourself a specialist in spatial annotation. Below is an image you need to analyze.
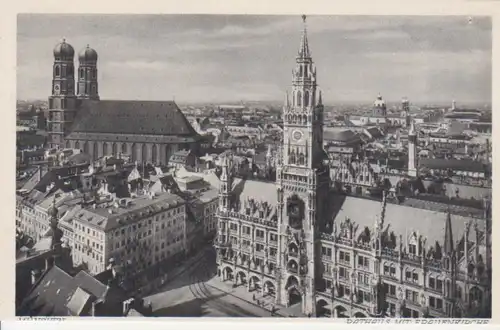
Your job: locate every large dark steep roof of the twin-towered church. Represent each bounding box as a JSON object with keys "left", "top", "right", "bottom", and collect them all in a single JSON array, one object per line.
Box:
[{"left": 72, "top": 100, "right": 197, "bottom": 136}]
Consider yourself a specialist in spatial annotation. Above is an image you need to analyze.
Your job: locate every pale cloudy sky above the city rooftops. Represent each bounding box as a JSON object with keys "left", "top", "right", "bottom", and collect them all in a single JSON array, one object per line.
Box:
[{"left": 17, "top": 14, "right": 492, "bottom": 104}]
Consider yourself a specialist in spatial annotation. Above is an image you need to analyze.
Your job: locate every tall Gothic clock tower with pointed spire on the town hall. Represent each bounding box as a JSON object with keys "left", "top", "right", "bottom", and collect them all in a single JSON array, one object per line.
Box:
[{"left": 276, "top": 15, "right": 330, "bottom": 315}]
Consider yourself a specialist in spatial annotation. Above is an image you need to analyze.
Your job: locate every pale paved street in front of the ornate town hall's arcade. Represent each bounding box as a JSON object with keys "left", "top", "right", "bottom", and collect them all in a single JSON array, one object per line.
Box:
[{"left": 144, "top": 247, "right": 278, "bottom": 317}]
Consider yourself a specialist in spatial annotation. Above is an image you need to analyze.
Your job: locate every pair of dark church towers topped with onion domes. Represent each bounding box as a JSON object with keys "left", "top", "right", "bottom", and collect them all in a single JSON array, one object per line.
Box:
[{"left": 47, "top": 40, "right": 99, "bottom": 148}]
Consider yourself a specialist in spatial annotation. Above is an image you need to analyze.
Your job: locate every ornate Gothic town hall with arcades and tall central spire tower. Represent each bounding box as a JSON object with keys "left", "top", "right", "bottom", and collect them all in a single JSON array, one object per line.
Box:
[{"left": 215, "top": 16, "right": 492, "bottom": 318}]
